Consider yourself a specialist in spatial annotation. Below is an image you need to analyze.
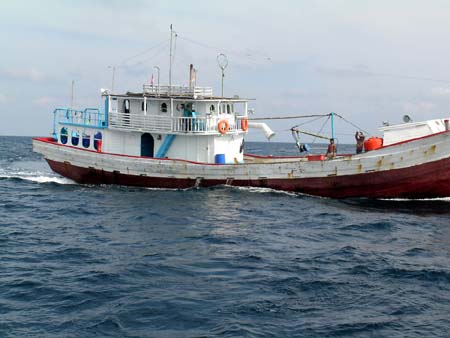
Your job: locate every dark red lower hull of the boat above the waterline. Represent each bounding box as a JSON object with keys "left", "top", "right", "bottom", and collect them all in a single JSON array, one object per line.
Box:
[{"left": 47, "top": 155, "right": 450, "bottom": 198}]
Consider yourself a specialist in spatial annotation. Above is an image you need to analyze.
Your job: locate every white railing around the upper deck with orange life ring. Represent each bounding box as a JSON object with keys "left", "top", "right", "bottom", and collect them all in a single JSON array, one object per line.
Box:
[{"left": 109, "top": 112, "right": 244, "bottom": 135}]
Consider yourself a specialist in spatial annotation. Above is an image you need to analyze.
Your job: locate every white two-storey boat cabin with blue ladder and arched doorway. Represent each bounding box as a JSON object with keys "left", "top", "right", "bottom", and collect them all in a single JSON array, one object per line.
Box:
[{"left": 53, "top": 85, "right": 248, "bottom": 164}]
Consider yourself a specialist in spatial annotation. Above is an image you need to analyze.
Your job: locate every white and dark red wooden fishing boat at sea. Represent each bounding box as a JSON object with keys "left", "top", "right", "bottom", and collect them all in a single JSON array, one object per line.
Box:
[{"left": 33, "top": 31, "right": 450, "bottom": 199}]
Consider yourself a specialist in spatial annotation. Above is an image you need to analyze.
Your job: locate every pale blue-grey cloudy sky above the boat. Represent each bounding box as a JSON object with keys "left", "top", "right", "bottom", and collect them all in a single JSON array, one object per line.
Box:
[{"left": 0, "top": 0, "right": 450, "bottom": 143}]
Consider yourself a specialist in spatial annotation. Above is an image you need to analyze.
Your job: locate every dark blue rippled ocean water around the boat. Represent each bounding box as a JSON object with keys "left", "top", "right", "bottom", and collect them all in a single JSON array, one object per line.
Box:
[{"left": 0, "top": 137, "right": 450, "bottom": 337}]
